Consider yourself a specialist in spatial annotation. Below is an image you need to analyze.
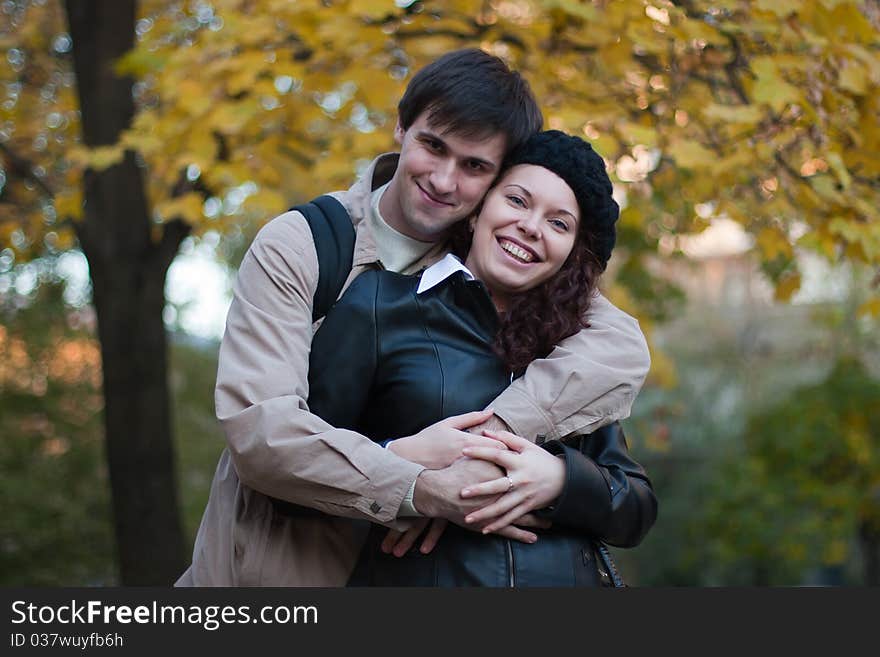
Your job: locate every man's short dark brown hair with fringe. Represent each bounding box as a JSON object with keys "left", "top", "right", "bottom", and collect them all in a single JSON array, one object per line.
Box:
[{"left": 397, "top": 48, "right": 544, "bottom": 151}]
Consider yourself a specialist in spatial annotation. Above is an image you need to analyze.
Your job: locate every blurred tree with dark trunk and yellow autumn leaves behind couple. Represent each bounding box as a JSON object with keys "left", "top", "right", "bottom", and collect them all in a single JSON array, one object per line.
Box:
[{"left": 0, "top": 0, "right": 880, "bottom": 583}]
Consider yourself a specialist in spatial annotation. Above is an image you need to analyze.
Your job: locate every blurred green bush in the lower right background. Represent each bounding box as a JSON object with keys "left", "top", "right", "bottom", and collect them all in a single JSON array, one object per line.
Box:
[{"left": 704, "top": 357, "right": 880, "bottom": 586}]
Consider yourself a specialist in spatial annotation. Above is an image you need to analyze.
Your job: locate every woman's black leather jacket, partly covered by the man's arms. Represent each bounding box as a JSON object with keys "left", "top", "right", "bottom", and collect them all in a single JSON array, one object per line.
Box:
[{"left": 309, "top": 271, "right": 657, "bottom": 586}]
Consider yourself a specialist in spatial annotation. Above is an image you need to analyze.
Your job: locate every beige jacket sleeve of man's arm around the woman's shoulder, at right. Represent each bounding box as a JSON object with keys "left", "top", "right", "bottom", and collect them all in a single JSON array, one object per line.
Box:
[{"left": 490, "top": 293, "right": 651, "bottom": 441}]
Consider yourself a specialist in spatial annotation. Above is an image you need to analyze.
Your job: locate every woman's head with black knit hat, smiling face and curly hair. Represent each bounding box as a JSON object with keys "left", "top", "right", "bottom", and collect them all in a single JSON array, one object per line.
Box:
[{"left": 470, "top": 130, "right": 619, "bottom": 372}]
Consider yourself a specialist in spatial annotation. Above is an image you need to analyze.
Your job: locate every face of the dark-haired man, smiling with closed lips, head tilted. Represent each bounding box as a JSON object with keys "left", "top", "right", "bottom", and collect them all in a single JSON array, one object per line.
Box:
[{"left": 379, "top": 112, "right": 506, "bottom": 242}]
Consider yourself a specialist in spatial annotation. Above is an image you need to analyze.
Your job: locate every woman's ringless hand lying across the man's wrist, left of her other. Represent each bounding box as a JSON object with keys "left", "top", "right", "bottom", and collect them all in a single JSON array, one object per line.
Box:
[{"left": 388, "top": 410, "right": 507, "bottom": 470}]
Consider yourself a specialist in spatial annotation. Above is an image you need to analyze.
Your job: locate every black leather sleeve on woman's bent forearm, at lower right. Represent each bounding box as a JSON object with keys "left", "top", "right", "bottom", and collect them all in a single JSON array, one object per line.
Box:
[{"left": 539, "top": 422, "right": 657, "bottom": 547}]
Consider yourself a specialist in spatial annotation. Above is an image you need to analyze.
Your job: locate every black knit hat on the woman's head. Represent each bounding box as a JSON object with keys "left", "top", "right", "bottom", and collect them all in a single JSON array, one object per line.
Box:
[{"left": 505, "top": 130, "right": 620, "bottom": 271}]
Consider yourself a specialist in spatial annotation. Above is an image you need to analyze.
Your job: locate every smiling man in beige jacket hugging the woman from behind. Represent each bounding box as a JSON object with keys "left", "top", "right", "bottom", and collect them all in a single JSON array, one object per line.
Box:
[{"left": 178, "top": 49, "right": 649, "bottom": 586}]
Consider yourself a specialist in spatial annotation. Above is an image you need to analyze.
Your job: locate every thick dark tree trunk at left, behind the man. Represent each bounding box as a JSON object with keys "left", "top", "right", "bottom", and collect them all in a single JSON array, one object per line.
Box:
[{"left": 65, "top": 0, "right": 188, "bottom": 586}]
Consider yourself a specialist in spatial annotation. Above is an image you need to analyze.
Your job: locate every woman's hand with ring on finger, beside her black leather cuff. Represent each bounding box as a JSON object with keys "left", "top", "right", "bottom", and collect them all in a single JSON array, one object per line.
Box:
[{"left": 461, "top": 431, "right": 565, "bottom": 534}]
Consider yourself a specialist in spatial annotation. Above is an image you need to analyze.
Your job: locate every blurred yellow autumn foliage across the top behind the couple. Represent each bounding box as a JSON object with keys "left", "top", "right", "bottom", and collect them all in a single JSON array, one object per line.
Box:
[{"left": 0, "top": 0, "right": 880, "bottom": 310}]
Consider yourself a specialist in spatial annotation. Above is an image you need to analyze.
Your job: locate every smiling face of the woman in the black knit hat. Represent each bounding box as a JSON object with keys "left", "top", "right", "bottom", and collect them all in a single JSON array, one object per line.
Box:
[{"left": 465, "top": 164, "right": 580, "bottom": 310}]
